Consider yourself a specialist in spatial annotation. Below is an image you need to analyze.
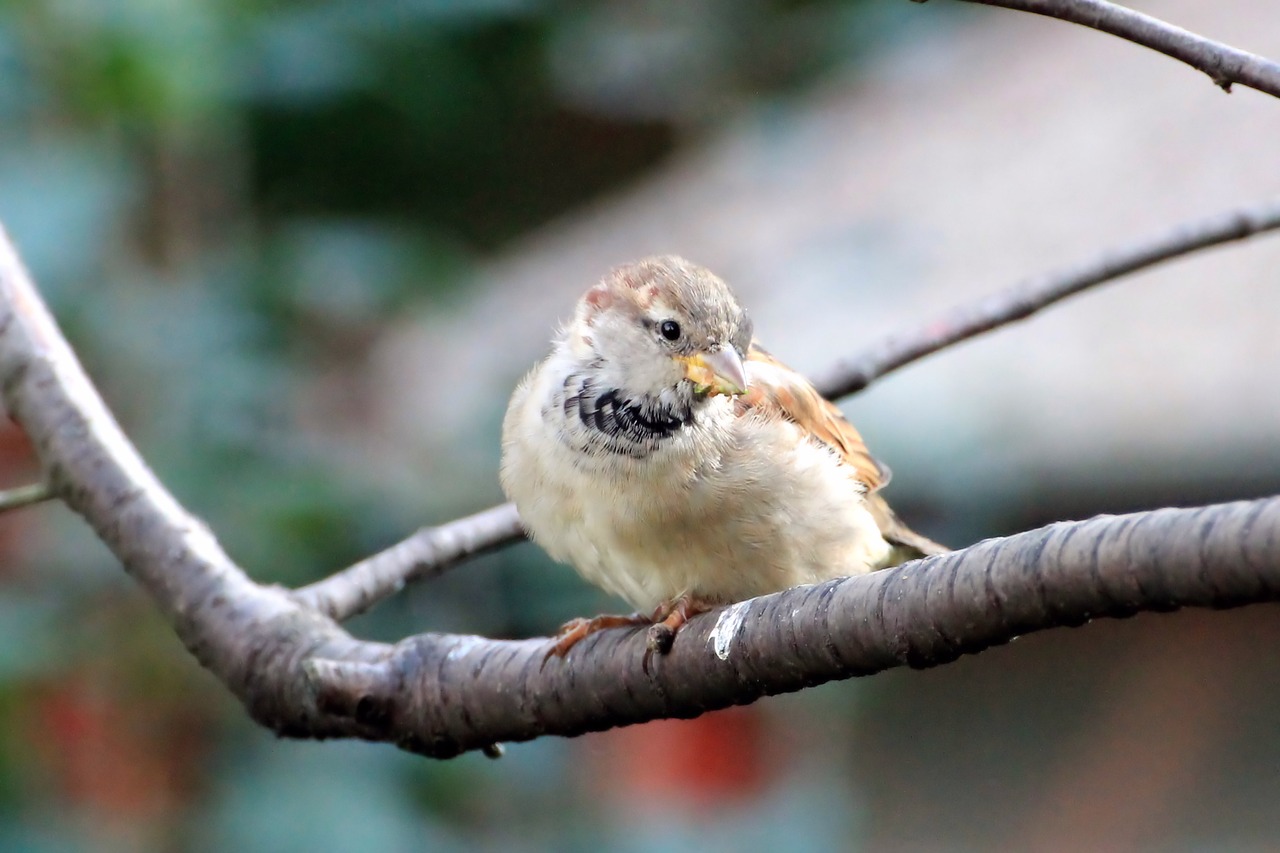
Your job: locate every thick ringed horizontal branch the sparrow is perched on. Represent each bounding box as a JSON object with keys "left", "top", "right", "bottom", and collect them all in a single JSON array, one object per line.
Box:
[{"left": 307, "top": 498, "right": 1280, "bottom": 757}]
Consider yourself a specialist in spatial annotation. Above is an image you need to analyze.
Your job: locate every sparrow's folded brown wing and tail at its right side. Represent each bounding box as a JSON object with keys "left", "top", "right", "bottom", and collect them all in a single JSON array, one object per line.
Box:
[{"left": 737, "top": 341, "right": 947, "bottom": 565}]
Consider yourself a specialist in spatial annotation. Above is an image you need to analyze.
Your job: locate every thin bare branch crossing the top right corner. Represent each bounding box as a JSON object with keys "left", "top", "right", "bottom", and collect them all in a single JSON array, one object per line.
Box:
[{"left": 942, "top": 0, "right": 1280, "bottom": 97}]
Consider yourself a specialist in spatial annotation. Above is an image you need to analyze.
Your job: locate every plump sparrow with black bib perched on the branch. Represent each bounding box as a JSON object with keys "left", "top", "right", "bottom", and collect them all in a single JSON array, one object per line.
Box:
[{"left": 502, "top": 256, "right": 946, "bottom": 653}]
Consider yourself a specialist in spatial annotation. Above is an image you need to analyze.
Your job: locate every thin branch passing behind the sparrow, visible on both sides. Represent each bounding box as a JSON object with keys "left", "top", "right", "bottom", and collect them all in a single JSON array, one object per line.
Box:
[{"left": 297, "top": 194, "right": 1280, "bottom": 621}]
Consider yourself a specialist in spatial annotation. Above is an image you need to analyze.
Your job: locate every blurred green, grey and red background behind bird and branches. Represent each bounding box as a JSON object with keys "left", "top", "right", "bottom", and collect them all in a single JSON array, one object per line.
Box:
[{"left": 0, "top": 0, "right": 1280, "bottom": 852}]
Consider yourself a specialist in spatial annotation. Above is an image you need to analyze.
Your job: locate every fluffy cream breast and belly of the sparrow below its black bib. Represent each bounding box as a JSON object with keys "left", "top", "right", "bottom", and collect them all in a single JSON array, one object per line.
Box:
[{"left": 502, "top": 364, "right": 888, "bottom": 612}]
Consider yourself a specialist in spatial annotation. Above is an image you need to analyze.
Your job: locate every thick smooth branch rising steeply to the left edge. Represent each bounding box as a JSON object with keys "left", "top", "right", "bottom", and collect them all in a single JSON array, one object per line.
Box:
[{"left": 0, "top": 224, "right": 388, "bottom": 738}]
